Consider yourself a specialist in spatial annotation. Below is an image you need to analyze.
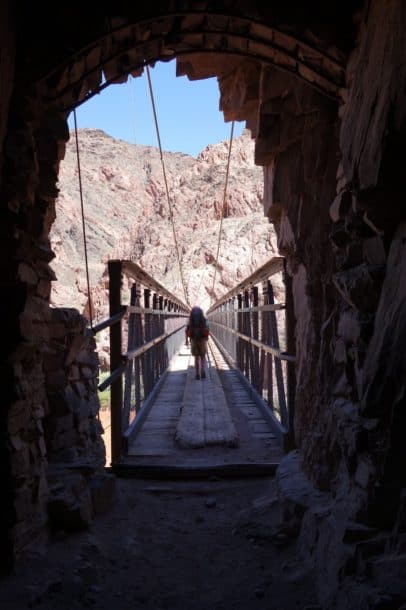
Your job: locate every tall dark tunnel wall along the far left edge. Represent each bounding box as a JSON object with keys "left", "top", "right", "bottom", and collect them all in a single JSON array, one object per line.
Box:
[{"left": 0, "top": 58, "right": 108, "bottom": 569}]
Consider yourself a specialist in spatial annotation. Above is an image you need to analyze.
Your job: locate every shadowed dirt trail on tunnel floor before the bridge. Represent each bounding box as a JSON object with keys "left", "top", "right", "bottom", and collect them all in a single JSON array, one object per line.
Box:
[{"left": 0, "top": 478, "right": 317, "bottom": 610}]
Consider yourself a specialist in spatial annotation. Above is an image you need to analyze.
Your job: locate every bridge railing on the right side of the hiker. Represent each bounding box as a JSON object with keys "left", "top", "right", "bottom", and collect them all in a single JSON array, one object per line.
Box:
[{"left": 207, "top": 257, "right": 295, "bottom": 448}]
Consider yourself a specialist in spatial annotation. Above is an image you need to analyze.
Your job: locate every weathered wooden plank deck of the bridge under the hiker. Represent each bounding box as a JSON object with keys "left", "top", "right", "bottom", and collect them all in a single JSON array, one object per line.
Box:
[{"left": 118, "top": 341, "right": 282, "bottom": 478}]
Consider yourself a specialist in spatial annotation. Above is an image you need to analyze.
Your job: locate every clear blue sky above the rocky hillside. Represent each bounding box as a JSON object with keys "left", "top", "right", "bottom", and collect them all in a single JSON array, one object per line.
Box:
[{"left": 69, "top": 61, "right": 244, "bottom": 156}]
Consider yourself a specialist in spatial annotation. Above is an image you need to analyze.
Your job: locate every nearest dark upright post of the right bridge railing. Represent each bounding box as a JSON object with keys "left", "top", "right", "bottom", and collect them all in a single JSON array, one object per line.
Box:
[{"left": 284, "top": 260, "right": 296, "bottom": 449}]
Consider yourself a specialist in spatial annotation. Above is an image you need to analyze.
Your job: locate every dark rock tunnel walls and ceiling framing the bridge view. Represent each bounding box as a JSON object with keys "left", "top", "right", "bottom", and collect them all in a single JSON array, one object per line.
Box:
[{"left": 0, "top": 0, "right": 406, "bottom": 608}]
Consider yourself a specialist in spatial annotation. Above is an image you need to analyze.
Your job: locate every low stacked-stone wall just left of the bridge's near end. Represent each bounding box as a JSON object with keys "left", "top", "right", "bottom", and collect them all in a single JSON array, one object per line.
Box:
[{"left": 43, "top": 309, "right": 114, "bottom": 531}]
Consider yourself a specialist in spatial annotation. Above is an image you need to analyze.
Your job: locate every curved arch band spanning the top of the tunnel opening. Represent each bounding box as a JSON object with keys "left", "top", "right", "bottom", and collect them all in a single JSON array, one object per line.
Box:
[{"left": 40, "top": 8, "right": 346, "bottom": 108}]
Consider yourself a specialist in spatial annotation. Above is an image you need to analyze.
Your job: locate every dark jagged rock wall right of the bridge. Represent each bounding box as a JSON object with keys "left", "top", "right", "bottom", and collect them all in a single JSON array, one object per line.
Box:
[{"left": 213, "top": 1, "right": 406, "bottom": 608}]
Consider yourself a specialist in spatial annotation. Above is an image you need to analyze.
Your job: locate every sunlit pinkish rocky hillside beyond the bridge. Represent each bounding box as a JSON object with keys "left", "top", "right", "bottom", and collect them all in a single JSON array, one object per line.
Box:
[{"left": 51, "top": 129, "right": 276, "bottom": 318}]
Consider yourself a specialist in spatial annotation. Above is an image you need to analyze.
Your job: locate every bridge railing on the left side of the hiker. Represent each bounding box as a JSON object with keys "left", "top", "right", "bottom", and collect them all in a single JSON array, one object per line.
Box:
[{"left": 93, "top": 260, "right": 189, "bottom": 464}]
